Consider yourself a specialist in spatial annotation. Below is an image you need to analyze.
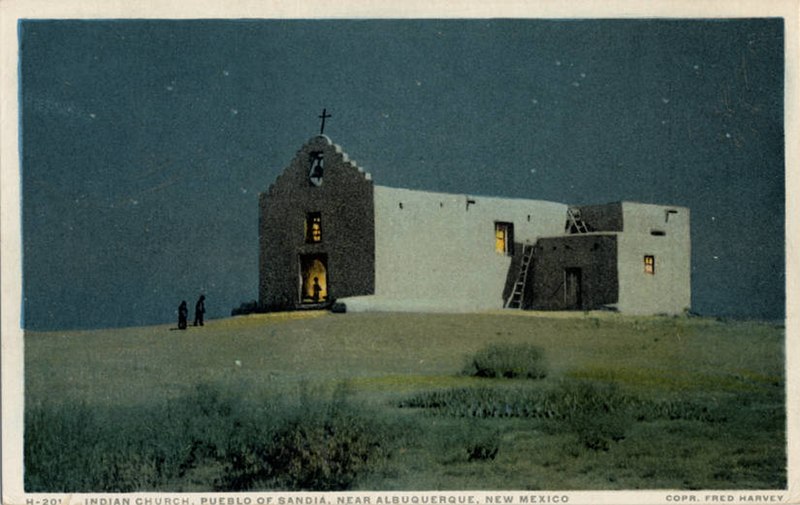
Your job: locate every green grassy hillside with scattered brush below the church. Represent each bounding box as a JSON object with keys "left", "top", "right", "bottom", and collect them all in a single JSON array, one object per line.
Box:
[{"left": 25, "top": 311, "right": 786, "bottom": 491}]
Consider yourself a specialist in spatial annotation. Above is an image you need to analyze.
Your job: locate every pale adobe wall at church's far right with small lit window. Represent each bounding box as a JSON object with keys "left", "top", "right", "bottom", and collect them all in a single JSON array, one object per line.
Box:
[{"left": 617, "top": 202, "right": 691, "bottom": 314}]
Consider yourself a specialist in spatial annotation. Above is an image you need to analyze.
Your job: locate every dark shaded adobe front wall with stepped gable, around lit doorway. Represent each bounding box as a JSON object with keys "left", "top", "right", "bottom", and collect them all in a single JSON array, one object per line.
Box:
[{"left": 259, "top": 135, "right": 375, "bottom": 310}]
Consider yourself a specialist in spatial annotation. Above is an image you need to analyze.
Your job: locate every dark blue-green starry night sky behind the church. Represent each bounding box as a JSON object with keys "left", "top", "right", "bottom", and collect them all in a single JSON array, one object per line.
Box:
[{"left": 19, "top": 19, "right": 785, "bottom": 330}]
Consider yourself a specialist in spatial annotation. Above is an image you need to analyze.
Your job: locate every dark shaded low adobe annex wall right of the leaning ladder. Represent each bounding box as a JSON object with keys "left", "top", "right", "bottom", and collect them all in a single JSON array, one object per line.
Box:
[{"left": 525, "top": 234, "right": 619, "bottom": 310}]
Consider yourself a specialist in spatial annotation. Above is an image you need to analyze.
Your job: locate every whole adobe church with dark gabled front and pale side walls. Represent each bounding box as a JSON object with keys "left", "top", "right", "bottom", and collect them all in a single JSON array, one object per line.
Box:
[{"left": 259, "top": 134, "right": 691, "bottom": 314}]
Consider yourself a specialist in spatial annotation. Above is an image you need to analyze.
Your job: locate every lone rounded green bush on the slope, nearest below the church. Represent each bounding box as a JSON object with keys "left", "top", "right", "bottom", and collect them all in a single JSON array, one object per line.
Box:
[{"left": 463, "top": 344, "right": 547, "bottom": 379}]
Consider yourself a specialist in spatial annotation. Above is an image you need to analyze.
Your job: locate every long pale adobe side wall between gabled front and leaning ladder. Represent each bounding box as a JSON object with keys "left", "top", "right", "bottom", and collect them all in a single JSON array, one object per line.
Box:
[{"left": 366, "top": 186, "right": 567, "bottom": 311}]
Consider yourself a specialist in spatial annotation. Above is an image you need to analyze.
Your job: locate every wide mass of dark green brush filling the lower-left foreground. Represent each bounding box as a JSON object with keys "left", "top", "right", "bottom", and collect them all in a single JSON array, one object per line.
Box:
[{"left": 24, "top": 385, "right": 400, "bottom": 492}]
